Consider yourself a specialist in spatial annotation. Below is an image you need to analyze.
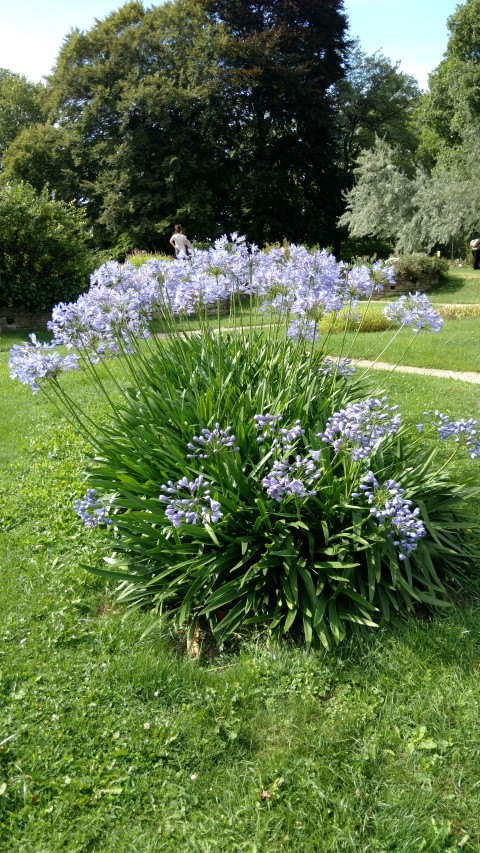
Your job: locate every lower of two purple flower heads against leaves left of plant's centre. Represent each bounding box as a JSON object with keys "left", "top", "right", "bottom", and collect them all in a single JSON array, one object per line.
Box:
[{"left": 159, "top": 474, "right": 223, "bottom": 527}]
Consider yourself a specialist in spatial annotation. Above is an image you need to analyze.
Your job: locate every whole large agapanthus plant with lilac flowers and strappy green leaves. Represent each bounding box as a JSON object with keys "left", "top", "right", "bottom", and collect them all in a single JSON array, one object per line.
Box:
[{"left": 11, "top": 235, "right": 479, "bottom": 646}]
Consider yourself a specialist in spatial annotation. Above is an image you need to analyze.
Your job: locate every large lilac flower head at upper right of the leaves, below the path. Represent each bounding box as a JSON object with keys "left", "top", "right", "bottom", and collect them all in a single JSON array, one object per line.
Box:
[{"left": 317, "top": 397, "right": 400, "bottom": 462}]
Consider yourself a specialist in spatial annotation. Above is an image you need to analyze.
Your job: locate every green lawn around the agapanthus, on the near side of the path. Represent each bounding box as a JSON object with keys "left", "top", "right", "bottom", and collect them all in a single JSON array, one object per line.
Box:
[{"left": 0, "top": 355, "right": 480, "bottom": 853}]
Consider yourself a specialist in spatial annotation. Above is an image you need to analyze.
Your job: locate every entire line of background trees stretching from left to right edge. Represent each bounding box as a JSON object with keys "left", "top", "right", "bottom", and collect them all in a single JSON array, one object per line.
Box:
[{"left": 4, "top": 0, "right": 480, "bottom": 256}]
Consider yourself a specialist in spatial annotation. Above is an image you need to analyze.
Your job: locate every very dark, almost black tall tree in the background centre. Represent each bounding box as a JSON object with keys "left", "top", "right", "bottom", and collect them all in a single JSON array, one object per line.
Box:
[{"left": 200, "top": 0, "right": 347, "bottom": 243}]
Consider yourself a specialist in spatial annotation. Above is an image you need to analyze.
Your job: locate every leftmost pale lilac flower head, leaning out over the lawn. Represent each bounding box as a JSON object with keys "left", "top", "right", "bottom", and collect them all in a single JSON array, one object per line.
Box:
[{"left": 8, "top": 334, "right": 78, "bottom": 393}]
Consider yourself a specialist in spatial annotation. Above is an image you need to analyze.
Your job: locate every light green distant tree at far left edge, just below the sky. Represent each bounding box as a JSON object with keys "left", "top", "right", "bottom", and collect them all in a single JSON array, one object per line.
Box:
[{"left": 0, "top": 68, "right": 44, "bottom": 162}]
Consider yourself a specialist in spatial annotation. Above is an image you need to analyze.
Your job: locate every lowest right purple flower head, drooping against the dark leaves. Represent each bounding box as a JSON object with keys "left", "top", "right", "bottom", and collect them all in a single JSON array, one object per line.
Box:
[{"left": 352, "top": 471, "right": 427, "bottom": 560}]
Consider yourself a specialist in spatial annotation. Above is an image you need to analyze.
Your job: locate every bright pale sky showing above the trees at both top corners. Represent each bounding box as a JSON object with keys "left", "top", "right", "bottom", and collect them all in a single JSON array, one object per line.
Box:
[{"left": 0, "top": 0, "right": 461, "bottom": 89}]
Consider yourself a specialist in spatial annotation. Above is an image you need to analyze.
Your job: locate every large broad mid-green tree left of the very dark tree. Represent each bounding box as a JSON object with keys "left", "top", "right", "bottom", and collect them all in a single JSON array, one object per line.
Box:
[{"left": 16, "top": 0, "right": 224, "bottom": 249}]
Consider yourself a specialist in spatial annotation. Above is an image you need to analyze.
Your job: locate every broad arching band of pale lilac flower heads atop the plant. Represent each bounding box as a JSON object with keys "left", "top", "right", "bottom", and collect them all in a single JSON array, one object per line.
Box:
[{"left": 11, "top": 234, "right": 441, "bottom": 390}]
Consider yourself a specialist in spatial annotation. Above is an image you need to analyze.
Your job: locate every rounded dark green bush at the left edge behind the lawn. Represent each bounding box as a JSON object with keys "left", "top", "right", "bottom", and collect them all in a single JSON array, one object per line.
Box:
[{"left": 0, "top": 183, "right": 93, "bottom": 311}]
